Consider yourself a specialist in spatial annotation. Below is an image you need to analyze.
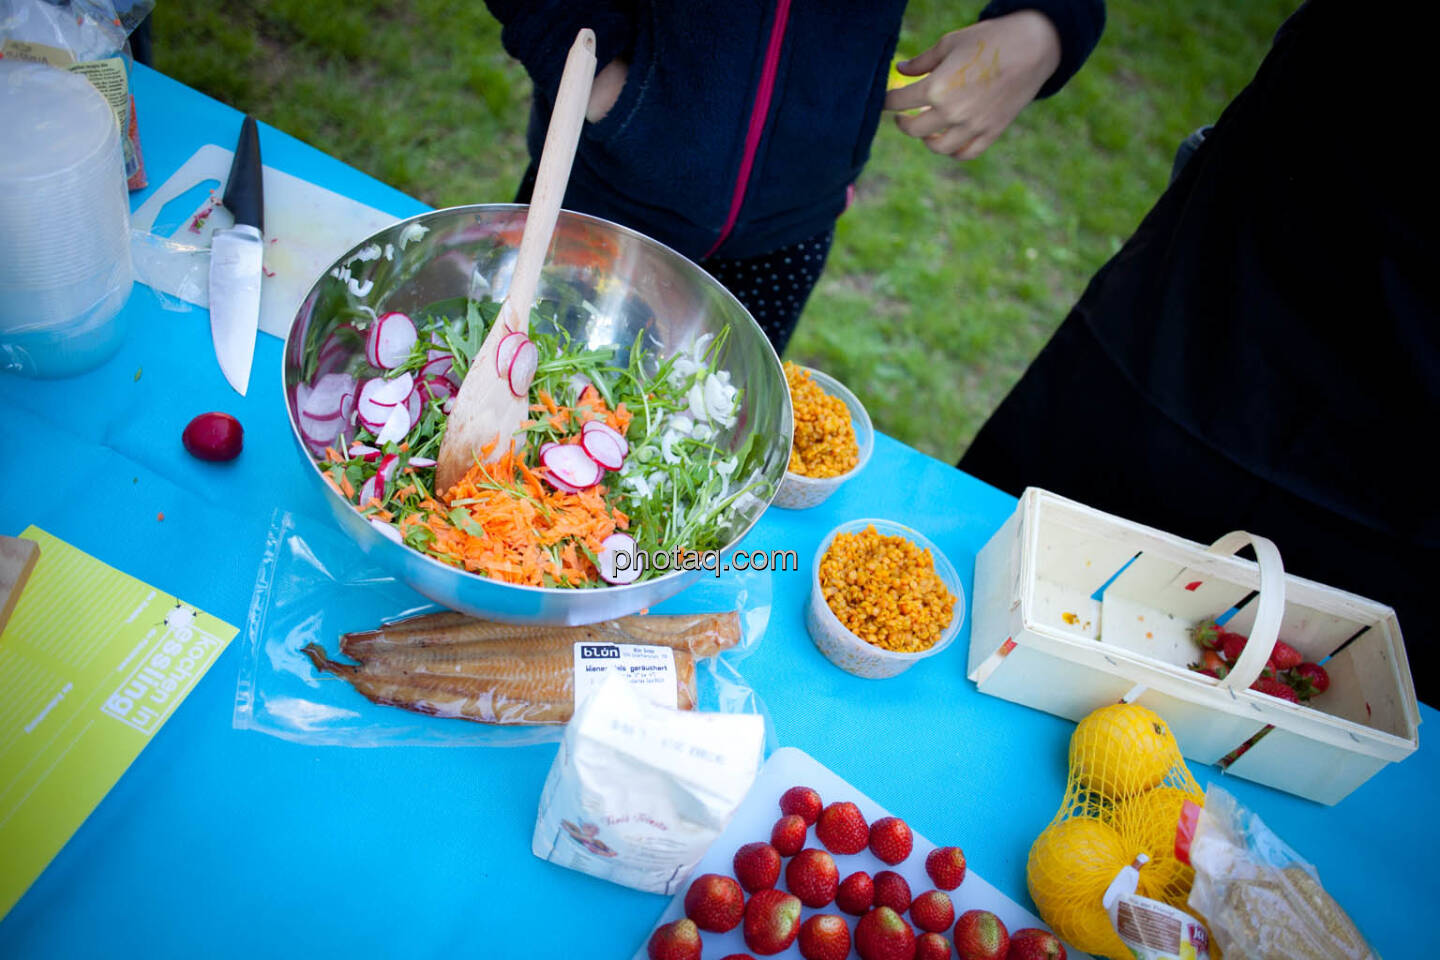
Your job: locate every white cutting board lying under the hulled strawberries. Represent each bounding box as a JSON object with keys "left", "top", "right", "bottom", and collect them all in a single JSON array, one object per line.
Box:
[{"left": 634, "top": 747, "right": 1093, "bottom": 960}]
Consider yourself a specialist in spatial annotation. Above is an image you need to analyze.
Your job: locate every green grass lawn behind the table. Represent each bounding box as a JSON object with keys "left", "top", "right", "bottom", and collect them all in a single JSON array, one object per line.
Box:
[{"left": 154, "top": 0, "right": 1296, "bottom": 461}]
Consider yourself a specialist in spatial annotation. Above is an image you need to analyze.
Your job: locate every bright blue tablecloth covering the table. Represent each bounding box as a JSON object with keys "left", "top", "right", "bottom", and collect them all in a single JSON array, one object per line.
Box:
[{"left": 0, "top": 68, "right": 1440, "bottom": 960}]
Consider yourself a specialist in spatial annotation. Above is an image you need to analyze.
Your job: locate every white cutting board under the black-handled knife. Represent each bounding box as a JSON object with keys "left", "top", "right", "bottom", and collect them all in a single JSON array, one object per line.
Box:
[{"left": 131, "top": 144, "right": 397, "bottom": 337}]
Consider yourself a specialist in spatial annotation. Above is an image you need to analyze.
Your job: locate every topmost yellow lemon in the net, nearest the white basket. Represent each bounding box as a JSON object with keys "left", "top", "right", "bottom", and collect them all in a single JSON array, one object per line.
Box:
[{"left": 1070, "top": 704, "right": 1185, "bottom": 799}]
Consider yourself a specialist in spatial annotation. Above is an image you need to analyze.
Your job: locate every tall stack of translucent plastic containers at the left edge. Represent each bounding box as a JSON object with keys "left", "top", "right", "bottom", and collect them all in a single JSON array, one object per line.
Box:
[{"left": 0, "top": 59, "right": 132, "bottom": 377}]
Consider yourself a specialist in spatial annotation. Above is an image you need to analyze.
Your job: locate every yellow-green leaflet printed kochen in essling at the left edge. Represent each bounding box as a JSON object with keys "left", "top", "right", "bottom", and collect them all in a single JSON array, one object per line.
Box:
[{"left": 0, "top": 527, "right": 236, "bottom": 915}]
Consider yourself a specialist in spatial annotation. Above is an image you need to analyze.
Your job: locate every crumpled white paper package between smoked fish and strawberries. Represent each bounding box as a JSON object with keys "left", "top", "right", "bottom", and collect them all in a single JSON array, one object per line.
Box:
[{"left": 531, "top": 672, "right": 765, "bottom": 894}]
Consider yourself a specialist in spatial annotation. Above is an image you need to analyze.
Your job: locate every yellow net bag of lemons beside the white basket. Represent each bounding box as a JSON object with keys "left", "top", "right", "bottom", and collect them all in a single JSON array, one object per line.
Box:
[{"left": 1025, "top": 702, "right": 1218, "bottom": 960}]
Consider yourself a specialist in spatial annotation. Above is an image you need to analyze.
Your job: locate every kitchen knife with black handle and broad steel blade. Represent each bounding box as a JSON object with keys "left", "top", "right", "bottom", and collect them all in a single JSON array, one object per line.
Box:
[{"left": 210, "top": 117, "right": 265, "bottom": 397}]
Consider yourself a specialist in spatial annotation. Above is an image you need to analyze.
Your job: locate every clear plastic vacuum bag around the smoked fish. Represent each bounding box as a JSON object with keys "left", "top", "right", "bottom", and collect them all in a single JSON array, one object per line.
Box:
[{"left": 233, "top": 510, "right": 775, "bottom": 751}]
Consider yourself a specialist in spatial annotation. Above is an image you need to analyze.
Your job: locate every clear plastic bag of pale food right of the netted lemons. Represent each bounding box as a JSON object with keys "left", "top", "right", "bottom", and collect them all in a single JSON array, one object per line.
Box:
[{"left": 1176, "top": 786, "right": 1380, "bottom": 960}]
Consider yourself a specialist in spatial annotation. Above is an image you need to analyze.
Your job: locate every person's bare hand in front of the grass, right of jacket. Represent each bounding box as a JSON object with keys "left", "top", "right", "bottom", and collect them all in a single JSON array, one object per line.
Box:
[{"left": 881, "top": 10, "right": 1060, "bottom": 160}]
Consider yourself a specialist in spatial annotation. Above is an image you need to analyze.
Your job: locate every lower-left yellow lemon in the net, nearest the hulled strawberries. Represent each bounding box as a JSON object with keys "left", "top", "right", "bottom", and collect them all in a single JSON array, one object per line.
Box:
[{"left": 1025, "top": 816, "right": 1139, "bottom": 957}]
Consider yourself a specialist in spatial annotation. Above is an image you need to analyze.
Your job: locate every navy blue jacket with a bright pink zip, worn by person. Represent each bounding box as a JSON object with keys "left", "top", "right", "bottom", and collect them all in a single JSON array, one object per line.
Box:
[{"left": 487, "top": 0, "right": 1104, "bottom": 259}]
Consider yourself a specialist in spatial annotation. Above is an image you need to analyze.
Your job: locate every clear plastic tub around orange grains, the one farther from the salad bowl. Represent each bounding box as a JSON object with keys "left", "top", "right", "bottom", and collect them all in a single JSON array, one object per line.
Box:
[{"left": 805, "top": 520, "right": 965, "bottom": 679}]
